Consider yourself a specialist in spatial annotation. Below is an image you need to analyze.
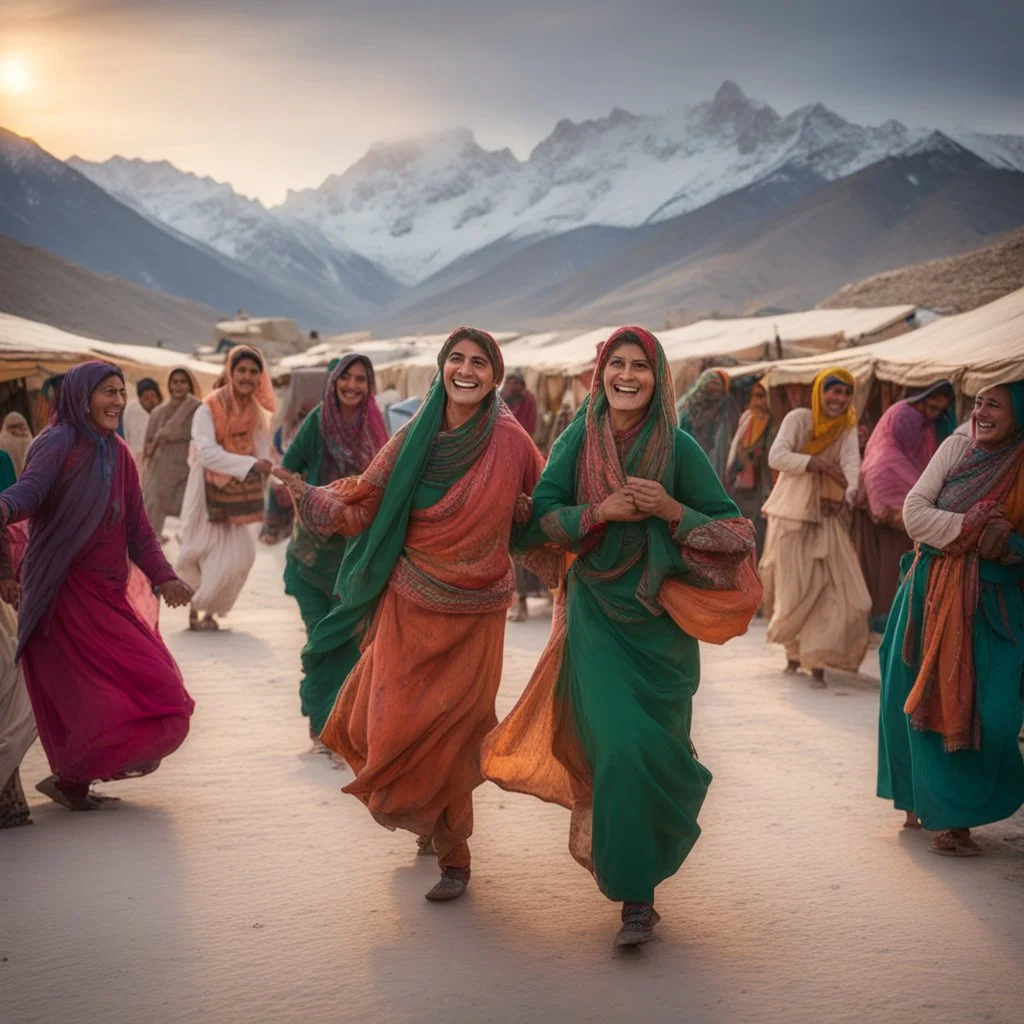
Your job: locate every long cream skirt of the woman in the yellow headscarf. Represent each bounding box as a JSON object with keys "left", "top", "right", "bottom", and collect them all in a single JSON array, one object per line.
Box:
[{"left": 761, "top": 516, "right": 871, "bottom": 672}]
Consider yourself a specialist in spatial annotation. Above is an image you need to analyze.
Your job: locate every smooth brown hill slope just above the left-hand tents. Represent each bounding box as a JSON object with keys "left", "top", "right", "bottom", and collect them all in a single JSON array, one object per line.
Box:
[{"left": 0, "top": 234, "right": 222, "bottom": 351}]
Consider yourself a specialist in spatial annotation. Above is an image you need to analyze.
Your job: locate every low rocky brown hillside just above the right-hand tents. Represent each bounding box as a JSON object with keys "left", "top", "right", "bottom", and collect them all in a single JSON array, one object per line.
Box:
[{"left": 819, "top": 227, "right": 1024, "bottom": 313}]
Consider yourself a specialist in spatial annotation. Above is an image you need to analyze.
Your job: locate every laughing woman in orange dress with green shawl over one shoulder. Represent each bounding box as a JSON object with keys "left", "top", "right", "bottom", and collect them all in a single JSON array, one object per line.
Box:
[{"left": 275, "top": 328, "right": 542, "bottom": 900}]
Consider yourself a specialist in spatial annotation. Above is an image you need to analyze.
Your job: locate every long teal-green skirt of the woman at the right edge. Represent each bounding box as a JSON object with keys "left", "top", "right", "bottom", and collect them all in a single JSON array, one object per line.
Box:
[{"left": 878, "top": 548, "right": 1024, "bottom": 830}]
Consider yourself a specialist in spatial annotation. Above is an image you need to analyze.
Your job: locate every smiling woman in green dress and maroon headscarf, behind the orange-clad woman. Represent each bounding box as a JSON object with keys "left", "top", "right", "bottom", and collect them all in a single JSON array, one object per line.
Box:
[{"left": 263, "top": 352, "right": 387, "bottom": 738}]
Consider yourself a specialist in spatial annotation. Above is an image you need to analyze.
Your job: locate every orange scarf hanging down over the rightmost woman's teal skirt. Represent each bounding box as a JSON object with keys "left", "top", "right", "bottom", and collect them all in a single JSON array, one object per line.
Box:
[{"left": 903, "top": 472, "right": 1024, "bottom": 752}]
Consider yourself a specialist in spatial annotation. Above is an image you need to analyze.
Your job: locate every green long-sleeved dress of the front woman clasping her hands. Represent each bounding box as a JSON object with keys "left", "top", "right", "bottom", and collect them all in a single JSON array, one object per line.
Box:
[{"left": 530, "top": 416, "right": 738, "bottom": 903}]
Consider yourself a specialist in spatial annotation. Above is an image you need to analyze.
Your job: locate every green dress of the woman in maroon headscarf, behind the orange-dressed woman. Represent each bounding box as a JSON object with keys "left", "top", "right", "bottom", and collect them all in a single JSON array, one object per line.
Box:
[{"left": 282, "top": 406, "right": 354, "bottom": 733}]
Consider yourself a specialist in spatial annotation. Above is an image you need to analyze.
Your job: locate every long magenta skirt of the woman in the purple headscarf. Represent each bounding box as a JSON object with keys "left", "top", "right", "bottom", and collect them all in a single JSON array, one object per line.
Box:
[{"left": 22, "top": 561, "right": 194, "bottom": 782}]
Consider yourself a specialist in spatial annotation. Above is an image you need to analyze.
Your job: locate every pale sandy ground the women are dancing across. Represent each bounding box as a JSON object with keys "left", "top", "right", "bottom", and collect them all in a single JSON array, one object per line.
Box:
[{"left": 0, "top": 550, "right": 1024, "bottom": 1024}]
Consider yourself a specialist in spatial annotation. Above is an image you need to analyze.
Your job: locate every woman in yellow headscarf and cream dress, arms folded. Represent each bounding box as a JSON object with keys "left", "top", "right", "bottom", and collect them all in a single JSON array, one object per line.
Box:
[{"left": 761, "top": 368, "right": 871, "bottom": 687}]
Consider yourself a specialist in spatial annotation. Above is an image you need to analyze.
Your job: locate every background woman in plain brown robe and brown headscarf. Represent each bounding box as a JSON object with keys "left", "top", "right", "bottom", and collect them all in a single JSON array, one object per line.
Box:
[{"left": 142, "top": 367, "right": 202, "bottom": 541}]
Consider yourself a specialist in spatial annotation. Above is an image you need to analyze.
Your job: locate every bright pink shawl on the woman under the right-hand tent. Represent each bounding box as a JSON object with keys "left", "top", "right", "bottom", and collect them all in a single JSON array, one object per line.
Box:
[{"left": 860, "top": 381, "right": 952, "bottom": 520}]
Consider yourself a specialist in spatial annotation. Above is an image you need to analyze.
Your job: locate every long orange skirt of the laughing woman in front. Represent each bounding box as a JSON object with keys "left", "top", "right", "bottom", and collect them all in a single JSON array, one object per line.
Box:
[{"left": 321, "top": 588, "right": 506, "bottom": 868}]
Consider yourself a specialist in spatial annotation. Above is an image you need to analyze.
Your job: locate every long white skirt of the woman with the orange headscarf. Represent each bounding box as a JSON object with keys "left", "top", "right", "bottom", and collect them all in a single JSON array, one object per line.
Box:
[{"left": 174, "top": 464, "right": 256, "bottom": 615}]
